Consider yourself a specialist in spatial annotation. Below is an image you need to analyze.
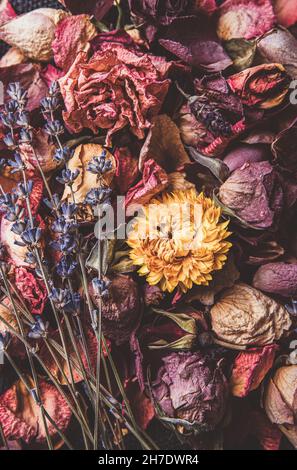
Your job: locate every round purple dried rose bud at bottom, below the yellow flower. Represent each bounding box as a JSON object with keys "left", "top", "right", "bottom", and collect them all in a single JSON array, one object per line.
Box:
[{"left": 152, "top": 352, "right": 228, "bottom": 432}]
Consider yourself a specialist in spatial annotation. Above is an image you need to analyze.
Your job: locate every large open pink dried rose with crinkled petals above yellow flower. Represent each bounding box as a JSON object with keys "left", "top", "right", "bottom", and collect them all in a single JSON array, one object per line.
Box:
[{"left": 60, "top": 37, "right": 172, "bottom": 145}]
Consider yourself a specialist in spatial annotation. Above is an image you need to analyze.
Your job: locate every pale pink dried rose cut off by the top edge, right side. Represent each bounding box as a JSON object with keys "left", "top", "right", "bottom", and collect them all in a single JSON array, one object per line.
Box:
[{"left": 217, "top": 0, "right": 275, "bottom": 41}]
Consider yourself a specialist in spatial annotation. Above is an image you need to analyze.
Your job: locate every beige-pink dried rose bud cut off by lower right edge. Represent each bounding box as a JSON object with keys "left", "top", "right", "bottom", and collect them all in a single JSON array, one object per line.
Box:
[{"left": 264, "top": 365, "right": 297, "bottom": 448}]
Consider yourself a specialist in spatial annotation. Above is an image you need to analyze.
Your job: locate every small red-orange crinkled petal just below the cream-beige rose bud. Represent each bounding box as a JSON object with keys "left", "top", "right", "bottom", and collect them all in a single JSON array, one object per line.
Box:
[{"left": 231, "top": 345, "right": 278, "bottom": 398}]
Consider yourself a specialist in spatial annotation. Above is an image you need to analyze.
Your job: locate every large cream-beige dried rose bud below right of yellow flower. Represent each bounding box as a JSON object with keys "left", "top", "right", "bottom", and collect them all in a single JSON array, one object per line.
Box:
[{"left": 210, "top": 283, "right": 291, "bottom": 346}]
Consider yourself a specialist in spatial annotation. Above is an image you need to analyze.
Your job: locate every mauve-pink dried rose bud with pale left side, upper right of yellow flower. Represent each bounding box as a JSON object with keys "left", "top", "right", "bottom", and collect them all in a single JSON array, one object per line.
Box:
[{"left": 219, "top": 162, "right": 283, "bottom": 229}]
